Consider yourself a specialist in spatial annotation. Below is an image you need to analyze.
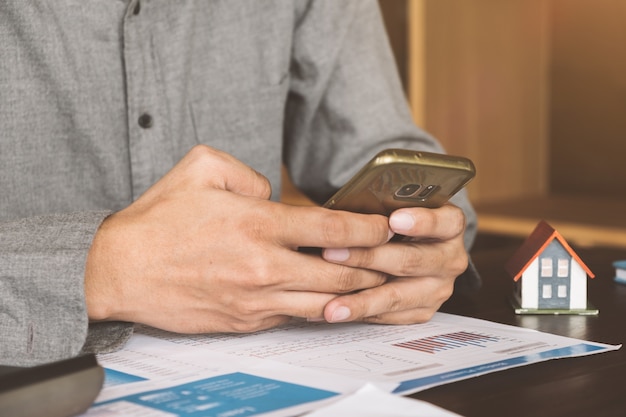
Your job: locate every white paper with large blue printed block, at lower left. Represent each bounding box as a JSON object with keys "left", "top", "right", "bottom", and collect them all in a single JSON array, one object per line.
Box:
[{"left": 86, "top": 333, "right": 380, "bottom": 417}]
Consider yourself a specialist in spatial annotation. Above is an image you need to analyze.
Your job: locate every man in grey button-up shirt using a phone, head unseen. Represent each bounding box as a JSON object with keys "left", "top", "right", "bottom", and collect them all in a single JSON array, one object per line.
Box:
[{"left": 0, "top": 0, "right": 476, "bottom": 365}]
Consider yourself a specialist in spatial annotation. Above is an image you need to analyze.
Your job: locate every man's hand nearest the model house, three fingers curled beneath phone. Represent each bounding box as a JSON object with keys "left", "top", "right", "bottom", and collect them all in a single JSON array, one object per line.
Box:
[{"left": 323, "top": 205, "right": 468, "bottom": 324}]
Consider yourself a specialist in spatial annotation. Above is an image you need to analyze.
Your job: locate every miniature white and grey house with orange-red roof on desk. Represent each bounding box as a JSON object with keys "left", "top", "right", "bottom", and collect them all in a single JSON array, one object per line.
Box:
[{"left": 505, "top": 221, "right": 598, "bottom": 314}]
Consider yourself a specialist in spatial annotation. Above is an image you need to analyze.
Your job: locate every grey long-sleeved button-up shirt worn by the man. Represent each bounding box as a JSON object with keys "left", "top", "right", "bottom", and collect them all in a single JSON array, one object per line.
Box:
[{"left": 0, "top": 0, "right": 475, "bottom": 364}]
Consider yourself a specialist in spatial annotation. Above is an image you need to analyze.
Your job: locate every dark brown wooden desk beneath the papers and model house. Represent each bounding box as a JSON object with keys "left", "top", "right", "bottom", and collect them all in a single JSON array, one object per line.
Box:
[{"left": 412, "top": 239, "right": 626, "bottom": 417}]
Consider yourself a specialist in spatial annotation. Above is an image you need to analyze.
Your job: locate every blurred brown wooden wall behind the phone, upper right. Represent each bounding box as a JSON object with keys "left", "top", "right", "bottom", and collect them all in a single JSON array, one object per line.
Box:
[{"left": 379, "top": 0, "right": 626, "bottom": 203}]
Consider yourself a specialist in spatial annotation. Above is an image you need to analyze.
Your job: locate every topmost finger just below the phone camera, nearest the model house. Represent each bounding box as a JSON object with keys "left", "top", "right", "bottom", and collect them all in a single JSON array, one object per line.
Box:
[{"left": 389, "top": 204, "right": 465, "bottom": 240}]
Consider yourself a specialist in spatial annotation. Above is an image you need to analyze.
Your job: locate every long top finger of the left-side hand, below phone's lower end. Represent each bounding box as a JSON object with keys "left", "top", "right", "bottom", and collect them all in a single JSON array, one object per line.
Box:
[{"left": 276, "top": 205, "right": 392, "bottom": 248}]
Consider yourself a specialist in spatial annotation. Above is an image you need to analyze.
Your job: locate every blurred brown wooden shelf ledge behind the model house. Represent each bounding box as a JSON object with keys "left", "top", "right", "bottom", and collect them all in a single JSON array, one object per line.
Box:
[{"left": 476, "top": 195, "right": 626, "bottom": 249}]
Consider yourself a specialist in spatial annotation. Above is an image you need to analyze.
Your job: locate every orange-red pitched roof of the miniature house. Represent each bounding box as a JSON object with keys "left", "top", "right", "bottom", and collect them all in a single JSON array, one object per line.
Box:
[{"left": 504, "top": 220, "right": 595, "bottom": 281}]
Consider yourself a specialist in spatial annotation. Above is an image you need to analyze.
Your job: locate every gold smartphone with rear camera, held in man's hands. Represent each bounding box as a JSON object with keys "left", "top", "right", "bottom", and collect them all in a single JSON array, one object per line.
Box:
[{"left": 324, "top": 149, "right": 476, "bottom": 216}]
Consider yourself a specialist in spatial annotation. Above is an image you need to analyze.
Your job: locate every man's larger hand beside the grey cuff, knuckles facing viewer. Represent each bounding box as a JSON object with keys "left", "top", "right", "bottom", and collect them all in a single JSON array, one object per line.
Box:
[{"left": 85, "top": 146, "right": 390, "bottom": 333}]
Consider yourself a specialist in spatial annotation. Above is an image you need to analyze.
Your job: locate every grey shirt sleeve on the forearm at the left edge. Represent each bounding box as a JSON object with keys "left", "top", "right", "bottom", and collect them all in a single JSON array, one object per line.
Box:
[{"left": 0, "top": 212, "right": 132, "bottom": 366}]
